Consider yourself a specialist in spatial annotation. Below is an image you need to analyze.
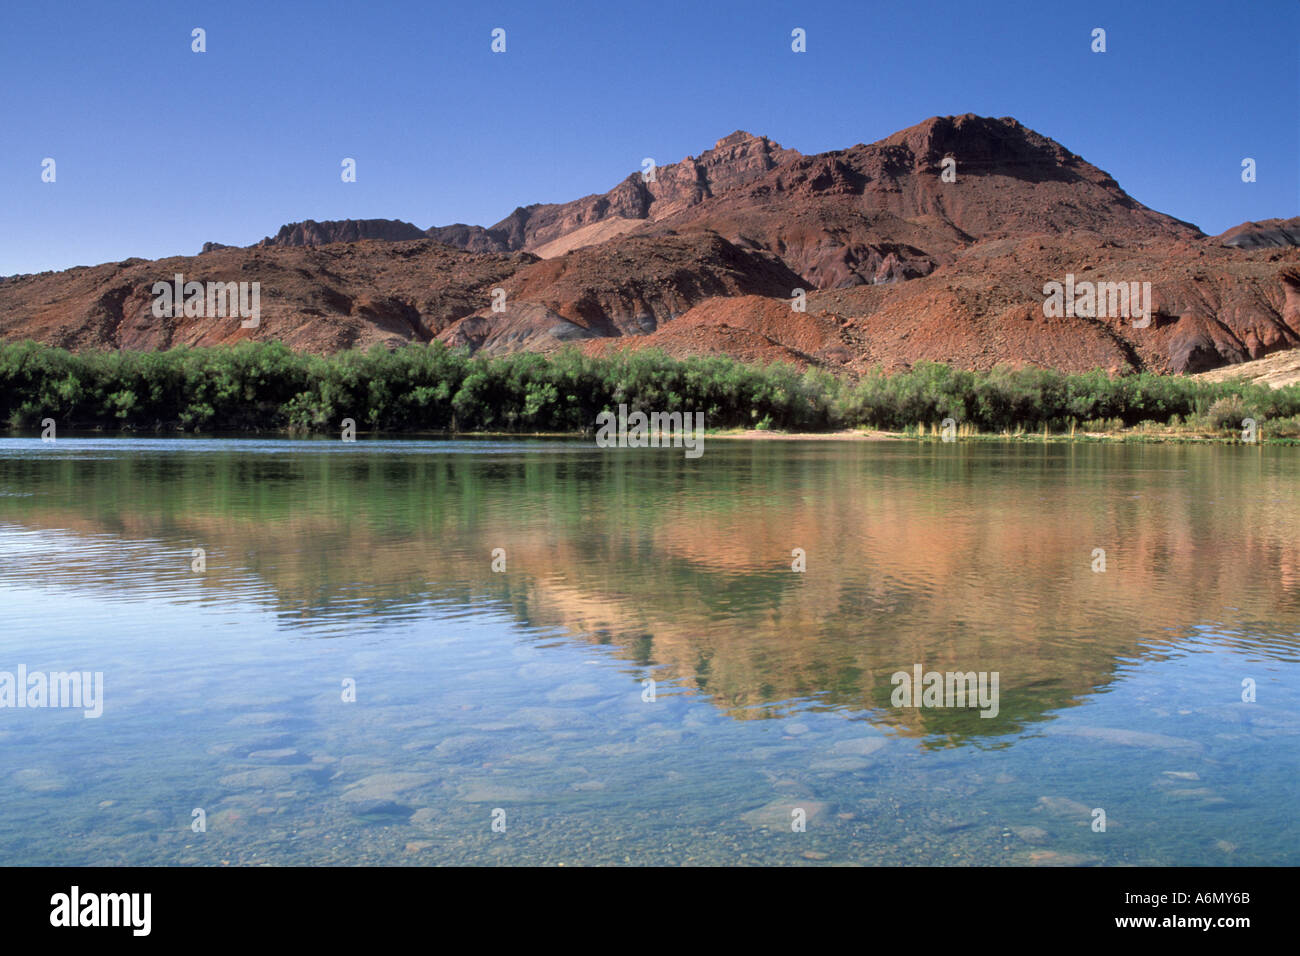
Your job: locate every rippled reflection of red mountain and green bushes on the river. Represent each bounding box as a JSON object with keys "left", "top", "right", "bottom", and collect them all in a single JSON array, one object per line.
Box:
[{"left": 0, "top": 441, "right": 1300, "bottom": 744}]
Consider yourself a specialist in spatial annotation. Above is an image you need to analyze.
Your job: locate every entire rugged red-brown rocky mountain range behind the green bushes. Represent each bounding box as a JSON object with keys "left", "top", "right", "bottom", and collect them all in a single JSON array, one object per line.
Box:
[{"left": 0, "top": 114, "right": 1300, "bottom": 372}]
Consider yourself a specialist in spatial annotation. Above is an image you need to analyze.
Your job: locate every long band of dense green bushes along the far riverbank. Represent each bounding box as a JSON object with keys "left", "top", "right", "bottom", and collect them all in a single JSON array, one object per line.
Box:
[{"left": 0, "top": 342, "right": 1300, "bottom": 438}]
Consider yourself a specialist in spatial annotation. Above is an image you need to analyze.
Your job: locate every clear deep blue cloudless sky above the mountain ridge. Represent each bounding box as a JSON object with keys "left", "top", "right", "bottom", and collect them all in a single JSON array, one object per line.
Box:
[{"left": 0, "top": 0, "right": 1300, "bottom": 274}]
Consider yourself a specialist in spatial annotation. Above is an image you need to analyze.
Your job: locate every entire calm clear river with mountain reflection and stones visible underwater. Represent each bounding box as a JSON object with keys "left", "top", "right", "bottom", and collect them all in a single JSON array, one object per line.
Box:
[{"left": 0, "top": 438, "right": 1300, "bottom": 865}]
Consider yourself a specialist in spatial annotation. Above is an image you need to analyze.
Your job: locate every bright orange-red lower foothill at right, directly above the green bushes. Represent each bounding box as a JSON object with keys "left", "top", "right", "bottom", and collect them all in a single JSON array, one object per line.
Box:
[{"left": 598, "top": 235, "right": 1300, "bottom": 372}]
